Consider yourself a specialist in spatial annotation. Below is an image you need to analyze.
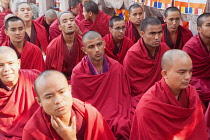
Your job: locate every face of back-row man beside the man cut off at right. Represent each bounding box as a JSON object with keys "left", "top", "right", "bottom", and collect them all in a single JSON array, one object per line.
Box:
[{"left": 164, "top": 11, "right": 181, "bottom": 32}]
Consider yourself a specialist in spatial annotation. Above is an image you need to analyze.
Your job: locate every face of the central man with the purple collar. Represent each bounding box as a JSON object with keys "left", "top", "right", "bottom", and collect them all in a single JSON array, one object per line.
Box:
[{"left": 82, "top": 36, "right": 105, "bottom": 62}]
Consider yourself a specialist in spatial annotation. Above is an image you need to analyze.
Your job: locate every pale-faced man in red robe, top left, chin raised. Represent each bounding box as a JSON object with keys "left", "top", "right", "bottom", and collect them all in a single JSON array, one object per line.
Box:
[{"left": 16, "top": 2, "right": 48, "bottom": 53}]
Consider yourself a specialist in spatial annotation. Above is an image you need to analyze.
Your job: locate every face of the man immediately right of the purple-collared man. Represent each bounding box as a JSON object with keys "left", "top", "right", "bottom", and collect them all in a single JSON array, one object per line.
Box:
[{"left": 140, "top": 24, "right": 162, "bottom": 48}]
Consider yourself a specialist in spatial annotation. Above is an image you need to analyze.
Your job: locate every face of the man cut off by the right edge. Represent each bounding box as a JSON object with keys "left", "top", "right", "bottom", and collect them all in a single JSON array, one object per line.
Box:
[{"left": 198, "top": 17, "right": 210, "bottom": 38}]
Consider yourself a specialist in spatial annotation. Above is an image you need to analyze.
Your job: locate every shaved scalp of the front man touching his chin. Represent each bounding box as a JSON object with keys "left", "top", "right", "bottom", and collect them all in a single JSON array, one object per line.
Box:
[{"left": 34, "top": 70, "right": 68, "bottom": 97}]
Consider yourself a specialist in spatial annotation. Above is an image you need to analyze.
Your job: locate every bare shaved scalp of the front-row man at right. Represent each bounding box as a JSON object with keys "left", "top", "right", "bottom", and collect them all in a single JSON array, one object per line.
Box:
[{"left": 161, "top": 49, "right": 190, "bottom": 70}]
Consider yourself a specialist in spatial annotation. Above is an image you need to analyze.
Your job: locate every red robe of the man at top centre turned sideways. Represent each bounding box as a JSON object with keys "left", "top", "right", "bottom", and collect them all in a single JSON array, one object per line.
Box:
[{"left": 81, "top": 10, "right": 111, "bottom": 37}]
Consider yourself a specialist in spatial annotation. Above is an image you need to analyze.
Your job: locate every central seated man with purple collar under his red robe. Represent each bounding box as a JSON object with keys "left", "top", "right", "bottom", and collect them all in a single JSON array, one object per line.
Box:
[{"left": 71, "top": 31, "right": 132, "bottom": 139}]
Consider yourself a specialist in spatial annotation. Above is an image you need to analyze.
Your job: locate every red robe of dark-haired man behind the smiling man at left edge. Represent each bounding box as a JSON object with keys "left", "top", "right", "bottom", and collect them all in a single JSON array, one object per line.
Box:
[{"left": 2, "top": 41, "right": 46, "bottom": 72}]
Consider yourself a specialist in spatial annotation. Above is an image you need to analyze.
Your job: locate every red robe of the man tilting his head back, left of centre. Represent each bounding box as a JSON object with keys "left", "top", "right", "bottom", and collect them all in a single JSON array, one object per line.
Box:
[{"left": 46, "top": 33, "right": 84, "bottom": 80}]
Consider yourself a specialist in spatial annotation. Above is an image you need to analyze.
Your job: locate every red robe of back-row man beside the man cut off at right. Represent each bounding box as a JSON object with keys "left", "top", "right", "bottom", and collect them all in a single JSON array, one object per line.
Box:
[{"left": 162, "top": 24, "right": 193, "bottom": 49}]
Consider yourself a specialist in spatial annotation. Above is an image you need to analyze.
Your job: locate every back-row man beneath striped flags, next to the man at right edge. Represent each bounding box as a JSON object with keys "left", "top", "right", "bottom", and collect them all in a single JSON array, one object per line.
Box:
[{"left": 162, "top": 7, "right": 193, "bottom": 49}]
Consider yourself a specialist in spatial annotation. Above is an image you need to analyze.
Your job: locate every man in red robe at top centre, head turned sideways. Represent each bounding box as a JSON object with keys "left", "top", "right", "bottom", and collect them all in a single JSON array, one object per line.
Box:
[{"left": 82, "top": 1, "right": 111, "bottom": 37}]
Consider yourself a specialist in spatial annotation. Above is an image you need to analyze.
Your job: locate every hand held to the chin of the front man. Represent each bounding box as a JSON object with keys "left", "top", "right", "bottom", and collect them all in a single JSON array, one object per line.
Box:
[{"left": 51, "top": 116, "right": 77, "bottom": 140}]
